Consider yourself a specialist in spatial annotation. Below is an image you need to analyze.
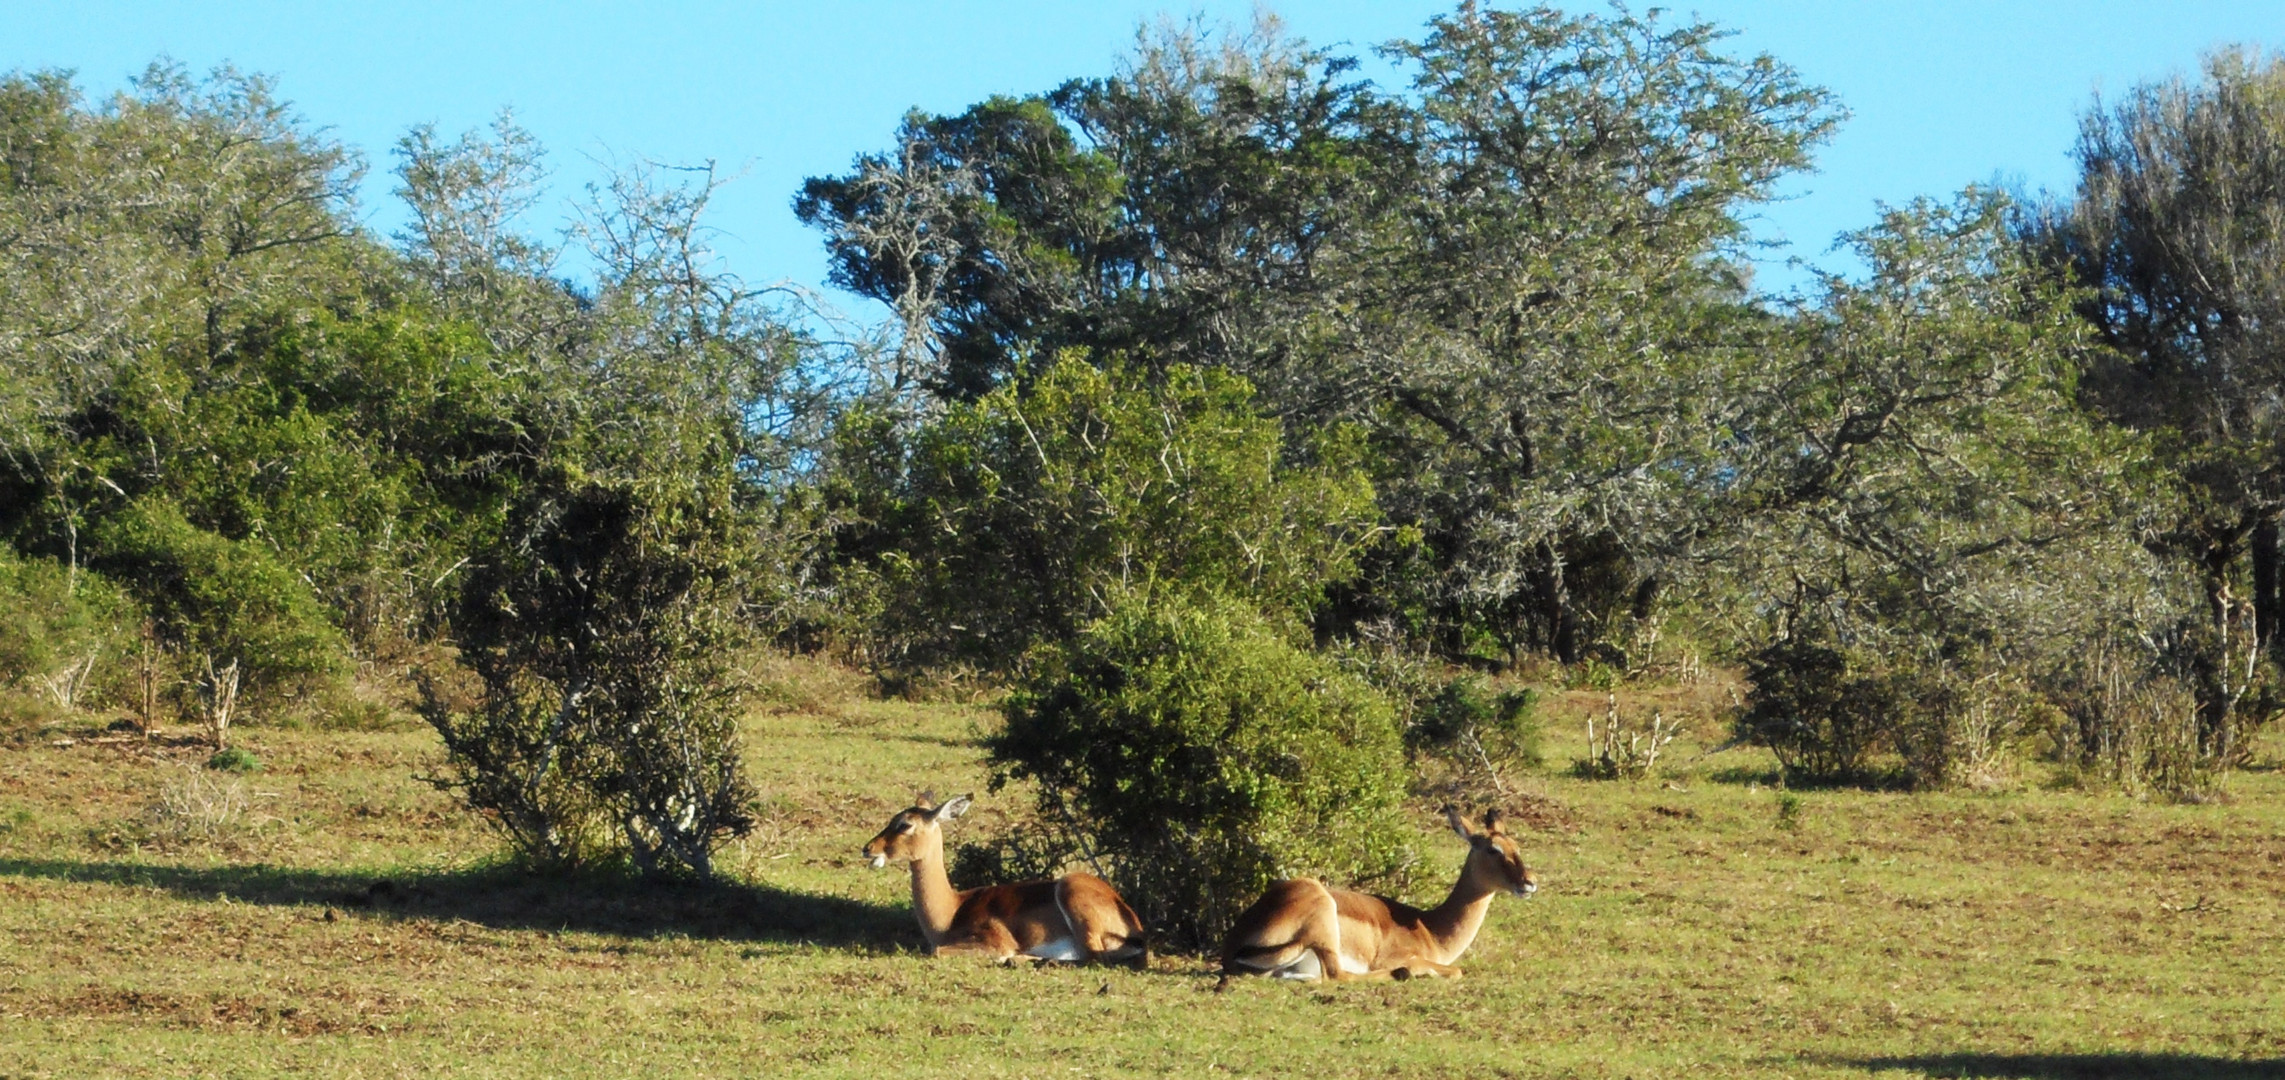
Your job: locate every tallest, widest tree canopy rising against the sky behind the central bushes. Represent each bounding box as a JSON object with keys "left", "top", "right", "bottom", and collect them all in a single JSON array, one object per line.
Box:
[{"left": 800, "top": 2, "right": 1833, "bottom": 660}]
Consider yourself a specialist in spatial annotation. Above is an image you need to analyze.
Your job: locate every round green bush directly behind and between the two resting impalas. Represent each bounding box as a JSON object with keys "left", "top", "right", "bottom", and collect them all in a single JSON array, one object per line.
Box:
[{"left": 989, "top": 594, "right": 1412, "bottom": 945}]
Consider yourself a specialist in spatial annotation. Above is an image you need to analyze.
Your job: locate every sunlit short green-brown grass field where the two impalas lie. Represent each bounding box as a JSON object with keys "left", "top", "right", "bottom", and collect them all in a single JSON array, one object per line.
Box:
[{"left": 0, "top": 666, "right": 2285, "bottom": 1078}]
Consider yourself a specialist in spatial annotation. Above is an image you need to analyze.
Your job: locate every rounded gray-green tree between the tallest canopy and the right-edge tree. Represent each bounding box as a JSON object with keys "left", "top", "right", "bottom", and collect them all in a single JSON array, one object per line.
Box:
[{"left": 1723, "top": 192, "right": 2182, "bottom": 783}]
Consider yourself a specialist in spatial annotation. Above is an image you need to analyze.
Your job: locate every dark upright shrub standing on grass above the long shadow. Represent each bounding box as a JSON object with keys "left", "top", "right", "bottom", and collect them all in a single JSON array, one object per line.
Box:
[{"left": 423, "top": 470, "right": 754, "bottom": 877}]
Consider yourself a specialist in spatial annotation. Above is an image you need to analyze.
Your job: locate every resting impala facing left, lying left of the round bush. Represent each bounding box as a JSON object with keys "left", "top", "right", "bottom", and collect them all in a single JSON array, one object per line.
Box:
[{"left": 864, "top": 795, "right": 1149, "bottom": 970}]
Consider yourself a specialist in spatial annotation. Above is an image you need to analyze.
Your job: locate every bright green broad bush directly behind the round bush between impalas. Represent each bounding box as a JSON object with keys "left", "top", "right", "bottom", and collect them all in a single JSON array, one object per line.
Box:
[{"left": 836, "top": 356, "right": 1376, "bottom": 669}]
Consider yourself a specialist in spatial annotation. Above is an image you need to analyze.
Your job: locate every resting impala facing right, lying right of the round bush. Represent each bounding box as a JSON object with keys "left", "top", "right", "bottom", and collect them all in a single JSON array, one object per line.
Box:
[{"left": 1222, "top": 806, "right": 1540, "bottom": 984}]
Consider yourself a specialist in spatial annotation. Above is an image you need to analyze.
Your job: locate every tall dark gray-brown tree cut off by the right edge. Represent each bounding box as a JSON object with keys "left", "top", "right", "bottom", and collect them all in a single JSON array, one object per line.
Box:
[{"left": 2029, "top": 50, "right": 2285, "bottom": 753}]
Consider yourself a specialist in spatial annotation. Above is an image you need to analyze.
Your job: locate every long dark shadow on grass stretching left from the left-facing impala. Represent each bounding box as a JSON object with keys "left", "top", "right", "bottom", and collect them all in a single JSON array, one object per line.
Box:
[{"left": 0, "top": 859, "right": 919, "bottom": 950}]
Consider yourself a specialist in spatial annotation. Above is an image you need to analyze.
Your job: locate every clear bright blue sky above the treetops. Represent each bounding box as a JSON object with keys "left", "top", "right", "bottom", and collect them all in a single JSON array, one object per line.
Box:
[{"left": 0, "top": 0, "right": 2285, "bottom": 303}]
